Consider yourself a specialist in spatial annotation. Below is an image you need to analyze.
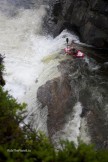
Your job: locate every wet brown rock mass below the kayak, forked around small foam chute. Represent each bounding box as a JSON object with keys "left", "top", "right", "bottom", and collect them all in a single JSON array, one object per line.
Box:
[{"left": 37, "top": 59, "right": 108, "bottom": 148}]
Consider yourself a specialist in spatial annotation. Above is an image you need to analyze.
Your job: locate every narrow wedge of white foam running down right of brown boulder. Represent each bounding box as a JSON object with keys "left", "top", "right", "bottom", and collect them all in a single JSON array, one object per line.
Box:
[{"left": 53, "top": 102, "right": 82, "bottom": 146}]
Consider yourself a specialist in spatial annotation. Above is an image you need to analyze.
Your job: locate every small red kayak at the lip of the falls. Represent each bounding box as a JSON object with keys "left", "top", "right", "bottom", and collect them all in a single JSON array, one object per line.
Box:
[{"left": 64, "top": 47, "right": 84, "bottom": 58}]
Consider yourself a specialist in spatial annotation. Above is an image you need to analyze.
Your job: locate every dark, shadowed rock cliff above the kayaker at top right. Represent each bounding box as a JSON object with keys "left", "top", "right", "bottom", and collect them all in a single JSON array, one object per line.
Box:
[{"left": 48, "top": 0, "right": 108, "bottom": 47}]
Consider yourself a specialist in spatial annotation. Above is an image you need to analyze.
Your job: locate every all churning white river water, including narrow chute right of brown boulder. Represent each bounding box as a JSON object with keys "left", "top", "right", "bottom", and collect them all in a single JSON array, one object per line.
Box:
[{"left": 0, "top": 0, "right": 107, "bottom": 147}]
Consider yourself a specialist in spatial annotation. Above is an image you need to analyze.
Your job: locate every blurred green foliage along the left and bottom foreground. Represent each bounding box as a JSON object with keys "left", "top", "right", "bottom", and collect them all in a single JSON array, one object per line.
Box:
[{"left": 0, "top": 54, "right": 108, "bottom": 162}]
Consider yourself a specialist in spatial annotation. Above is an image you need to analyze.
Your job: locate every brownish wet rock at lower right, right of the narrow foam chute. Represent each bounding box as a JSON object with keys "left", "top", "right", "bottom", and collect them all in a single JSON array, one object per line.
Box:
[{"left": 87, "top": 108, "right": 108, "bottom": 149}]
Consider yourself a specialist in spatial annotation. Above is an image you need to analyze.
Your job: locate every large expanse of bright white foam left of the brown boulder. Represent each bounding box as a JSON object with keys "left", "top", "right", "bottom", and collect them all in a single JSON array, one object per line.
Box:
[{"left": 0, "top": 3, "right": 77, "bottom": 134}]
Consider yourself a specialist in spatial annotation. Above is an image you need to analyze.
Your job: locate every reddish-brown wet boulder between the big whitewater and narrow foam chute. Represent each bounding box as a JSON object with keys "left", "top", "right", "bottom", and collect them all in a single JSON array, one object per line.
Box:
[{"left": 37, "top": 60, "right": 76, "bottom": 137}]
